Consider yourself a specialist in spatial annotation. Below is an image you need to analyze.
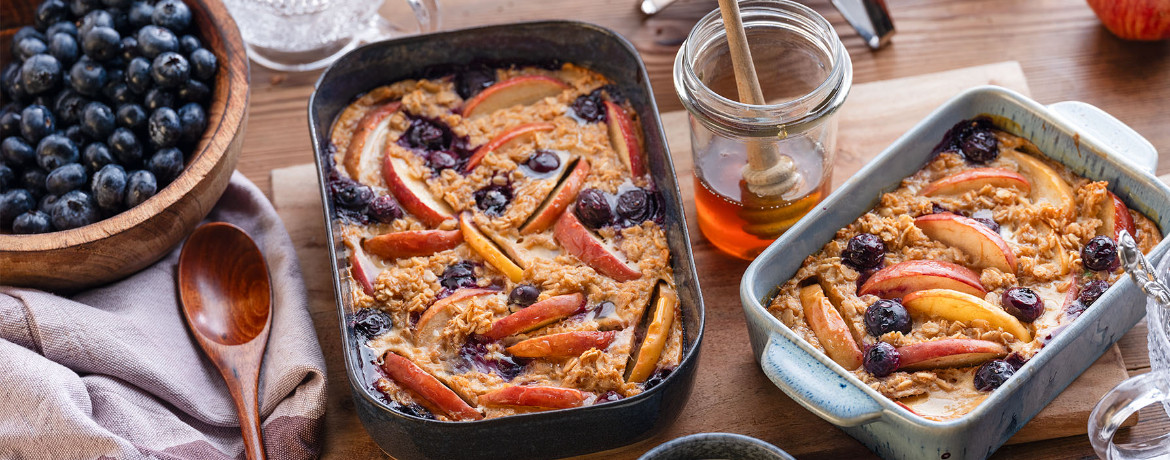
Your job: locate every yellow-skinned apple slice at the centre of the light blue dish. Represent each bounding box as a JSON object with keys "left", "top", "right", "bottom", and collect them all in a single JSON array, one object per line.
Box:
[{"left": 902, "top": 289, "right": 1032, "bottom": 342}]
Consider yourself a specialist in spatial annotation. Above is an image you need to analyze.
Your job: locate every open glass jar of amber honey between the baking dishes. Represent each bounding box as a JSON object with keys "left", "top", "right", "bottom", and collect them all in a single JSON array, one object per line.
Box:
[{"left": 674, "top": 0, "right": 853, "bottom": 260}]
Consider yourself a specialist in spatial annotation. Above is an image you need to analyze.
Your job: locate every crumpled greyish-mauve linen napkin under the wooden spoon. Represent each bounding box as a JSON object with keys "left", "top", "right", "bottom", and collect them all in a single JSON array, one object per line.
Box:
[{"left": 0, "top": 172, "right": 325, "bottom": 460}]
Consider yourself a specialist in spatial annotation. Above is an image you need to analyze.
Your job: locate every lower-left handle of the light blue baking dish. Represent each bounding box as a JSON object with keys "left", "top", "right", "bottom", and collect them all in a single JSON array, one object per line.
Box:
[{"left": 759, "top": 334, "right": 882, "bottom": 426}]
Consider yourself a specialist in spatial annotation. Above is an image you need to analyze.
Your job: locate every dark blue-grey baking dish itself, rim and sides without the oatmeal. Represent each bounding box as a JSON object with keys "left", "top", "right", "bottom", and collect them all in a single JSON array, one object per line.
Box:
[{"left": 307, "top": 21, "right": 704, "bottom": 460}]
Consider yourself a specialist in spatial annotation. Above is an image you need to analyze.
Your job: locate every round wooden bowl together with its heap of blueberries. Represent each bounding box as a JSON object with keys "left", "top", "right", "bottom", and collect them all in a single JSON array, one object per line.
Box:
[{"left": 0, "top": 0, "right": 248, "bottom": 291}]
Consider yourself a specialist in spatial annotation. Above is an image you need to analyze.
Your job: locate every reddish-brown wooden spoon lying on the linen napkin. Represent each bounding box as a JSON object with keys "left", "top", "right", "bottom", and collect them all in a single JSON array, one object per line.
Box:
[{"left": 179, "top": 222, "right": 273, "bottom": 460}]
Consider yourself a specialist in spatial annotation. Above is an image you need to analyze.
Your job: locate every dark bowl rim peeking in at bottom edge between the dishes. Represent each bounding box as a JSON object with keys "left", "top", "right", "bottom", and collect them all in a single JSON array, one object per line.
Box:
[{"left": 638, "top": 433, "right": 794, "bottom": 460}]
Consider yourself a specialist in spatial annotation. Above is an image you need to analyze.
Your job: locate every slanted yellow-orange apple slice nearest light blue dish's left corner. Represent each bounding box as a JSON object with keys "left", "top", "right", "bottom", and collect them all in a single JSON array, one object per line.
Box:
[{"left": 800, "top": 284, "right": 861, "bottom": 371}]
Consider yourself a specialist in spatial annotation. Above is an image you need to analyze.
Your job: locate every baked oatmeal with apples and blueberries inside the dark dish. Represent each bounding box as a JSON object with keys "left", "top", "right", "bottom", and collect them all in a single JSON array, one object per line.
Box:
[{"left": 328, "top": 64, "right": 683, "bottom": 420}]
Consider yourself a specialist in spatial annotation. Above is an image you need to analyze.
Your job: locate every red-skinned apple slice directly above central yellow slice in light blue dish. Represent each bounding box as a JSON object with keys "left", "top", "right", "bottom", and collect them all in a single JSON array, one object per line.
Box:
[{"left": 858, "top": 260, "right": 987, "bottom": 298}]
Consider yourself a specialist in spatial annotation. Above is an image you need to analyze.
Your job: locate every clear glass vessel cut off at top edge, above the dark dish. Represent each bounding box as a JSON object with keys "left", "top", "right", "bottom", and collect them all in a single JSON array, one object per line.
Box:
[{"left": 223, "top": 0, "right": 439, "bottom": 71}]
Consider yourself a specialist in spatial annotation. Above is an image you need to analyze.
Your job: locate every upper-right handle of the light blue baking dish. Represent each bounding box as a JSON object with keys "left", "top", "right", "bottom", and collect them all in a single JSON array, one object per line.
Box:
[{"left": 1048, "top": 101, "right": 1158, "bottom": 174}]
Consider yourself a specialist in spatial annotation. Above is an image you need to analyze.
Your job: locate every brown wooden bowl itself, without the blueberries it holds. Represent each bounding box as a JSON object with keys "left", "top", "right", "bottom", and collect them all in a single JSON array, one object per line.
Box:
[{"left": 0, "top": 0, "right": 249, "bottom": 291}]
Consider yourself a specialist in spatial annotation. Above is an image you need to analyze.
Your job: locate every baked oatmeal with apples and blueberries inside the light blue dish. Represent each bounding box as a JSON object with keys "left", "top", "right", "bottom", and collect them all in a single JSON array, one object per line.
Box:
[{"left": 769, "top": 117, "right": 1161, "bottom": 420}]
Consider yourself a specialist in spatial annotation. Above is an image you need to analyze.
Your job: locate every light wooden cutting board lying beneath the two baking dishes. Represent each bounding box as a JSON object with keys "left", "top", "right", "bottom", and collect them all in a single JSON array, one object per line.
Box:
[{"left": 271, "top": 62, "right": 1136, "bottom": 459}]
